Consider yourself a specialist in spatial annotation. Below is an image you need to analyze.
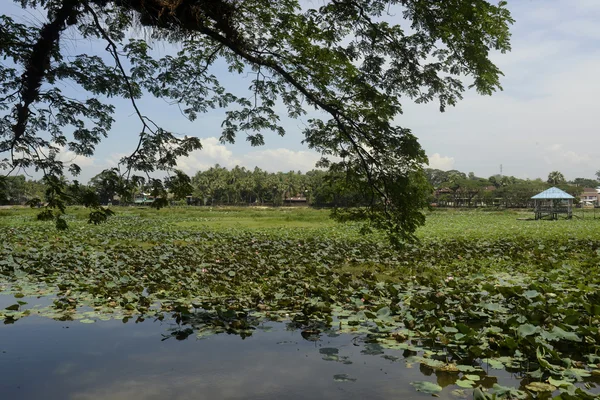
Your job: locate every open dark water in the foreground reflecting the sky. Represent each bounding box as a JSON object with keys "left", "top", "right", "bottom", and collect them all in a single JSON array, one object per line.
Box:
[{"left": 0, "top": 296, "right": 596, "bottom": 400}]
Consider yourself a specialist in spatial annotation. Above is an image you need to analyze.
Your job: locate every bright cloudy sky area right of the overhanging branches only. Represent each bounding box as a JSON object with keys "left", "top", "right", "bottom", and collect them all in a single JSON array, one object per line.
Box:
[{"left": 398, "top": 0, "right": 600, "bottom": 179}]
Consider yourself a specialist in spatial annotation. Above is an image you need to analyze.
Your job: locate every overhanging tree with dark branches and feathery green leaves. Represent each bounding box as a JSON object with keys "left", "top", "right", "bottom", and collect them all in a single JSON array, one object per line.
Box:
[{"left": 0, "top": 0, "right": 512, "bottom": 244}]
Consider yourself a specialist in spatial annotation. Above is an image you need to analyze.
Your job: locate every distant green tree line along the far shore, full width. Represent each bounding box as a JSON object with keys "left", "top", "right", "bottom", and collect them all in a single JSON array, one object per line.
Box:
[{"left": 0, "top": 164, "right": 600, "bottom": 208}]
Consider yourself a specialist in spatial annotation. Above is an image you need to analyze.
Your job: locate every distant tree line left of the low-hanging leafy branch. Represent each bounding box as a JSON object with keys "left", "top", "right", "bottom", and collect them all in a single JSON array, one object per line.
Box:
[{"left": 0, "top": 164, "right": 366, "bottom": 207}]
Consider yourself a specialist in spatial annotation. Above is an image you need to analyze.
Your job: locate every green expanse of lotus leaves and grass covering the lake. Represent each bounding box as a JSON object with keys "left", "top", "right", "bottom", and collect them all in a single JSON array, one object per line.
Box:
[{"left": 0, "top": 208, "right": 600, "bottom": 398}]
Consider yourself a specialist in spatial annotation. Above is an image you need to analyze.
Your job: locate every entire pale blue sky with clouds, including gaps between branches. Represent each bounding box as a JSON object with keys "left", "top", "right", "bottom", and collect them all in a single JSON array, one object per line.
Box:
[{"left": 0, "top": 0, "right": 600, "bottom": 181}]
